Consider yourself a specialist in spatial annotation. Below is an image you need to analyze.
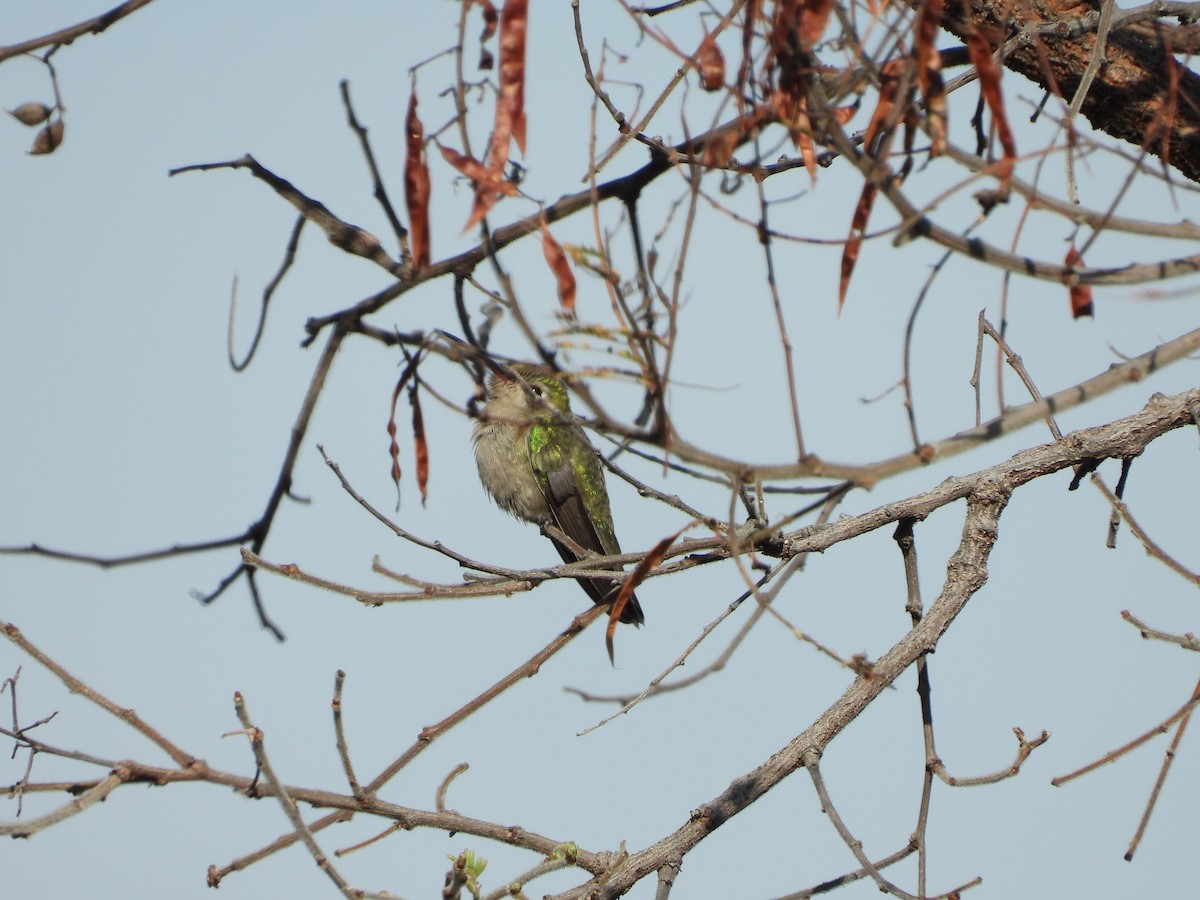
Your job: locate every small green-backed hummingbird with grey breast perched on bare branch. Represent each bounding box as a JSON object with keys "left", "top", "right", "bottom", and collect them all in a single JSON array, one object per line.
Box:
[{"left": 473, "top": 364, "right": 646, "bottom": 625}]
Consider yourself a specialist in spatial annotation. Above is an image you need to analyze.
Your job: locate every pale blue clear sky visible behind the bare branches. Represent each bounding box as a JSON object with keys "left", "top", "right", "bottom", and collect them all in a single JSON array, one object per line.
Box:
[{"left": 0, "top": 0, "right": 1200, "bottom": 899}]
